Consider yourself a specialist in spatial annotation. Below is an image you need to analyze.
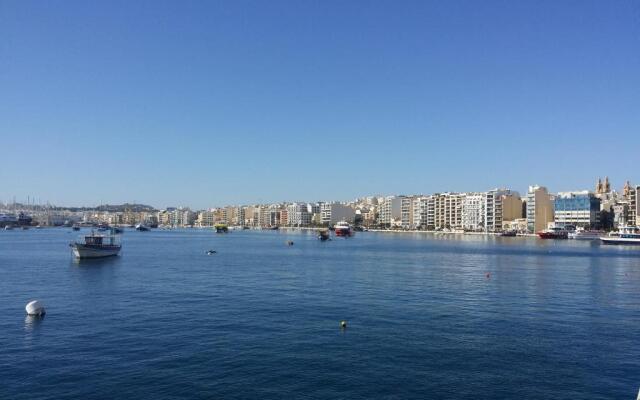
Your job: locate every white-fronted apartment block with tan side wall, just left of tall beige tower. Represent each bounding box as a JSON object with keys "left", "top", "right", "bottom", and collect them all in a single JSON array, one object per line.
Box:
[{"left": 484, "top": 189, "right": 522, "bottom": 232}]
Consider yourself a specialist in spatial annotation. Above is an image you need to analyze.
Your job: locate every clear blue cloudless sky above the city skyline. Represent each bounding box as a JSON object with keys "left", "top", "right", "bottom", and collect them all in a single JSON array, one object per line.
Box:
[{"left": 0, "top": 0, "right": 640, "bottom": 208}]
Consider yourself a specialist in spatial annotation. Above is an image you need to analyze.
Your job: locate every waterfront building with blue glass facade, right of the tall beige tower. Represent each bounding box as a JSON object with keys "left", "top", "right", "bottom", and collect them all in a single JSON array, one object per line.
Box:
[{"left": 553, "top": 190, "right": 601, "bottom": 228}]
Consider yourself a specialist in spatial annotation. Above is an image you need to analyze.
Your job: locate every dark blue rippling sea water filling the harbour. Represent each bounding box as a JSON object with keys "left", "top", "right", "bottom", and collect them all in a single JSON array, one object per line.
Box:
[{"left": 0, "top": 228, "right": 640, "bottom": 400}]
